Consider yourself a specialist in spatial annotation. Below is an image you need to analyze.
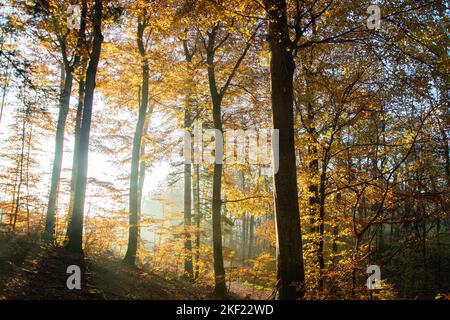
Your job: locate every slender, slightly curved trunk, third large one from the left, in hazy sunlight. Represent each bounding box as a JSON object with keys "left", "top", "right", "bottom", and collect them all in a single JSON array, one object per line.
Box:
[{"left": 123, "top": 12, "right": 150, "bottom": 265}]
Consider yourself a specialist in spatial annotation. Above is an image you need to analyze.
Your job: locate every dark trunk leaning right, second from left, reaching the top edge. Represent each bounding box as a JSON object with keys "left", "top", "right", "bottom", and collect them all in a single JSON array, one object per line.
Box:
[{"left": 67, "top": 0, "right": 103, "bottom": 254}]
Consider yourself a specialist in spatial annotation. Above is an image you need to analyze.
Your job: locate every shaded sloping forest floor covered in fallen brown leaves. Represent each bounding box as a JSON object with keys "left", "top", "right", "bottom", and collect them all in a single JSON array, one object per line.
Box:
[{"left": 0, "top": 234, "right": 264, "bottom": 300}]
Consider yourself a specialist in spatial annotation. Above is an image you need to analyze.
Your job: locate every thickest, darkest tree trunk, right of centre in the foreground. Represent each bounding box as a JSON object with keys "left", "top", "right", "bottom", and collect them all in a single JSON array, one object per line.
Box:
[{"left": 264, "top": 0, "right": 305, "bottom": 299}]
